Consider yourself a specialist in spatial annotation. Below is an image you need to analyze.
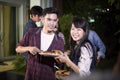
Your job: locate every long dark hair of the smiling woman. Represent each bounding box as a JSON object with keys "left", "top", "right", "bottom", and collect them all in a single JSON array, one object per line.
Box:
[{"left": 70, "top": 16, "right": 89, "bottom": 64}]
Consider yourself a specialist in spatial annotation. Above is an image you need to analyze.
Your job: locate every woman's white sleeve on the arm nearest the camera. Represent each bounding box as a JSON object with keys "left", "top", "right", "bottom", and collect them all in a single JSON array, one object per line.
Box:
[{"left": 78, "top": 47, "right": 93, "bottom": 77}]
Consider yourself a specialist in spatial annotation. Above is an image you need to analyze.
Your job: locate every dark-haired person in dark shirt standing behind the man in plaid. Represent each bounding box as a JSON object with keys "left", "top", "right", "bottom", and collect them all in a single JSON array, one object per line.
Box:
[{"left": 22, "top": 6, "right": 43, "bottom": 60}]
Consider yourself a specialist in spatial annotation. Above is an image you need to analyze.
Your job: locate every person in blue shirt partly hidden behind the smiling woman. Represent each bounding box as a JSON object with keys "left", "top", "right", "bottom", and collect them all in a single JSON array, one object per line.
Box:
[{"left": 88, "top": 30, "right": 106, "bottom": 62}]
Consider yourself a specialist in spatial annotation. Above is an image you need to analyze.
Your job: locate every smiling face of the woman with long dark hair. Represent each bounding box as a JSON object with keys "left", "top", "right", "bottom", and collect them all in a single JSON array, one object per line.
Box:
[{"left": 70, "top": 24, "right": 85, "bottom": 43}]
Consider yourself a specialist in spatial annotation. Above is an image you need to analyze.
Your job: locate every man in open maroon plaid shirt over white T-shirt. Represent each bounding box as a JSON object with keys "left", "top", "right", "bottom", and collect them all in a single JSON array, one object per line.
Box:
[{"left": 16, "top": 7, "right": 64, "bottom": 80}]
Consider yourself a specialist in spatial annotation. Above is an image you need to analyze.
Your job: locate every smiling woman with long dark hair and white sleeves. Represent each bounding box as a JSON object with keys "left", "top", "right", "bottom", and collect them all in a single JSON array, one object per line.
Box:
[{"left": 57, "top": 17, "right": 95, "bottom": 77}]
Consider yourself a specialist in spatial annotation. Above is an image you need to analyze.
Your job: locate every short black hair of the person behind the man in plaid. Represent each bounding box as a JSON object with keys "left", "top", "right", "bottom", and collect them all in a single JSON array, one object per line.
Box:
[{"left": 30, "top": 6, "right": 43, "bottom": 16}]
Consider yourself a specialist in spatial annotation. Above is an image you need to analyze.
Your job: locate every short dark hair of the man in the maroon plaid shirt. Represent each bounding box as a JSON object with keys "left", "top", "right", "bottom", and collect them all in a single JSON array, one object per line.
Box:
[{"left": 43, "top": 7, "right": 60, "bottom": 17}]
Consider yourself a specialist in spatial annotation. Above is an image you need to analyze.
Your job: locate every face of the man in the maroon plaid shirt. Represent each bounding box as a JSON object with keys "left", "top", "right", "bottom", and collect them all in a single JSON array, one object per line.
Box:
[{"left": 42, "top": 14, "right": 58, "bottom": 31}]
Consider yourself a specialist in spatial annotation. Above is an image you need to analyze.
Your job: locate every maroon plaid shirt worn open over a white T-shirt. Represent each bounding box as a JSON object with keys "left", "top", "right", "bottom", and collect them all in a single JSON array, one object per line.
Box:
[{"left": 17, "top": 28, "right": 64, "bottom": 80}]
